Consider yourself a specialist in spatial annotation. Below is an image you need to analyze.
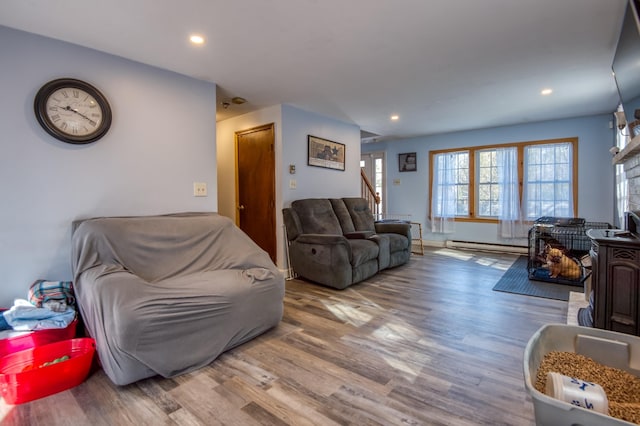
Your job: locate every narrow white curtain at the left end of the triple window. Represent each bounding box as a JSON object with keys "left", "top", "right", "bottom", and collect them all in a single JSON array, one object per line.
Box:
[{"left": 431, "top": 153, "right": 457, "bottom": 233}]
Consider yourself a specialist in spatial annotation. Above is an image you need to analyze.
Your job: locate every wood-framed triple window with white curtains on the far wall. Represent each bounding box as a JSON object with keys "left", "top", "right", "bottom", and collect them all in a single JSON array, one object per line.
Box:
[{"left": 430, "top": 138, "right": 578, "bottom": 222}]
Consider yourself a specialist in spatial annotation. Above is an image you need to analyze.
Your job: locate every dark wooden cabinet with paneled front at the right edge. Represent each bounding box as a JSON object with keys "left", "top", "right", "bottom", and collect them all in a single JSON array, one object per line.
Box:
[{"left": 587, "top": 229, "right": 640, "bottom": 336}]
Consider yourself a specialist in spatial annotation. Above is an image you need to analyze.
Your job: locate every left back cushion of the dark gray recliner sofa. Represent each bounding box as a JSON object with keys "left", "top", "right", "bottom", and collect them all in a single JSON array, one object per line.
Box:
[{"left": 291, "top": 198, "right": 342, "bottom": 235}]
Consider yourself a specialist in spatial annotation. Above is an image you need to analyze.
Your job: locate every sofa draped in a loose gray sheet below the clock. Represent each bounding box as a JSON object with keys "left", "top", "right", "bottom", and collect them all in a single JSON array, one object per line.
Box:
[{"left": 72, "top": 213, "right": 284, "bottom": 385}]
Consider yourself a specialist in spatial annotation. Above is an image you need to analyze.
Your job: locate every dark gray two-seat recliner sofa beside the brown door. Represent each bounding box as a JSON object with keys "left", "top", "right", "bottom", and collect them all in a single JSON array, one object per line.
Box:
[{"left": 282, "top": 198, "right": 411, "bottom": 289}]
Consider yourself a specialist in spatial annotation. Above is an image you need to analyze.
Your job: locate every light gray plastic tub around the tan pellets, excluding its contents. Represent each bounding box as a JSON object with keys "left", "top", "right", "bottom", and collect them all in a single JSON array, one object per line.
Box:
[{"left": 524, "top": 324, "right": 640, "bottom": 426}]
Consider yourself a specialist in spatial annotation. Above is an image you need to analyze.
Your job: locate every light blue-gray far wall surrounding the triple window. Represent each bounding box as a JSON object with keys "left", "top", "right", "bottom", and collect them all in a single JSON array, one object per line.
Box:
[{"left": 362, "top": 115, "right": 614, "bottom": 245}]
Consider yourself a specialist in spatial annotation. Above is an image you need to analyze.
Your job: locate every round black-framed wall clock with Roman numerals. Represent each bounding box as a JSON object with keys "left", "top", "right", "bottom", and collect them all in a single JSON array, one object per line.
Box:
[{"left": 33, "top": 78, "right": 111, "bottom": 144}]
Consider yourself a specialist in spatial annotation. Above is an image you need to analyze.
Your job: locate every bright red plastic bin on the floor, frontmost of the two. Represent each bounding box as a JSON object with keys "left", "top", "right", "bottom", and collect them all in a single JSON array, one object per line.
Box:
[{"left": 0, "top": 337, "right": 96, "bottom": 404}]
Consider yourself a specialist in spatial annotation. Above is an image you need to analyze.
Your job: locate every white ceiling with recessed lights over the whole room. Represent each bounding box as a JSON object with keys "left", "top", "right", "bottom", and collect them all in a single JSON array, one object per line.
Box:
[{"left": 0, "top": 0, "right": 626, "bottom": 140}]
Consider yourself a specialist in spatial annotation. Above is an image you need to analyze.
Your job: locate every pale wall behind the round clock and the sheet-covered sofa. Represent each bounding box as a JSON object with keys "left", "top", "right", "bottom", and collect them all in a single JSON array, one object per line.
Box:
[{"left": 0, "top": 27, "right": 217, "bottom": 306}]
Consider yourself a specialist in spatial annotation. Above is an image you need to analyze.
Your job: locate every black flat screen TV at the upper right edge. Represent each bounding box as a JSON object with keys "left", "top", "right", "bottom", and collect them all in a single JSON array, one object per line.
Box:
[{"left": 612, "top": 0, "right": 640, "bottom": 123}]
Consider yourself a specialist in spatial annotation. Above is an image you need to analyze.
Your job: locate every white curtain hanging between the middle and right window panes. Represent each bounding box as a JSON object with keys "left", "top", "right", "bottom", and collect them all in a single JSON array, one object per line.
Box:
[{"left": 496, "top": 147, "right": 527, "bottom": 239}]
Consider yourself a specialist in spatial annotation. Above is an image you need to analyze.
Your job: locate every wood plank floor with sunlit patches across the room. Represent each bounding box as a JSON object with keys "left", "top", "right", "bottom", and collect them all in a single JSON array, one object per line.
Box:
[{"left": 0, "top": 248, "right": 567, "bottom": 426}]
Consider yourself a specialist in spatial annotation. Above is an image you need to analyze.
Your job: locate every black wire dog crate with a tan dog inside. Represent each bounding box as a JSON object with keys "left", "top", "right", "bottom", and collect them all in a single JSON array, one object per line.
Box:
[{"left": 527, "top": 216, "right": 611, "bottom": 286}]
